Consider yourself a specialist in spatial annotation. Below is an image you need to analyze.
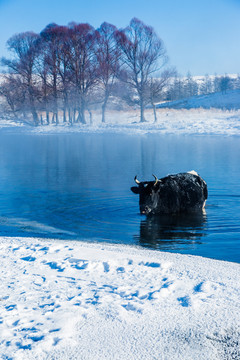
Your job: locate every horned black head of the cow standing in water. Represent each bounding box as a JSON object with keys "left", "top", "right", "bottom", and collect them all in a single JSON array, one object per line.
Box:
[{"left": 131, "top": 175, "right": 161, "bottom": 215}]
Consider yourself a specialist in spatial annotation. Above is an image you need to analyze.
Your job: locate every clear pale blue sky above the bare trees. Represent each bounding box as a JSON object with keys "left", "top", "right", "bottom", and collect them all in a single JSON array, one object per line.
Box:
[{"left": 0, "top": 0, "right": 240, "bottom": 75}]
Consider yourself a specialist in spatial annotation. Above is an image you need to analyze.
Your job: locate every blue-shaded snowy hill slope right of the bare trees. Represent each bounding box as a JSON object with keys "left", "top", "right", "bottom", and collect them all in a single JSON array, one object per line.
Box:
[{"left": 157, "top": 89, "right": 240, "bottom": 110}]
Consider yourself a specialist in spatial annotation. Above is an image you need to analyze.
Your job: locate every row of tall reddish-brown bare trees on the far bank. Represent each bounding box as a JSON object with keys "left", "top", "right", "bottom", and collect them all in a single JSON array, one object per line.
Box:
[{"left": 0, "top": 18, "right": 172, "bottom": 125}]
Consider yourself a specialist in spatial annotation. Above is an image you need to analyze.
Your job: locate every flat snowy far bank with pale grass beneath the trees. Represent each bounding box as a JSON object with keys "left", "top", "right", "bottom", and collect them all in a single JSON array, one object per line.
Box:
[{"left": 0, "top": 109, "right": 240, "bottom": 136}]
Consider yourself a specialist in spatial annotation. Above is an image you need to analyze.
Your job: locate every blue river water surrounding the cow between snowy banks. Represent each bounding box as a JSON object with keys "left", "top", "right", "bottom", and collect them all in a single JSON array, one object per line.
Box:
[{"left": 0, "top": 131, "right": 240, "bottom": 262}]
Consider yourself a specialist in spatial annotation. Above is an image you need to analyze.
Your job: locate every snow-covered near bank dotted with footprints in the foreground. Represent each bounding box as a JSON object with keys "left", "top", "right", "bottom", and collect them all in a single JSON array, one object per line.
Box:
[{"left": 0, "top": 238, "right": 240, "bottom": 360}]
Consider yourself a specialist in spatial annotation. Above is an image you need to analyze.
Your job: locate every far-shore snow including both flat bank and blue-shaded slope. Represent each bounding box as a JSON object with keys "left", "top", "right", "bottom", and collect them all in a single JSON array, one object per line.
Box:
[{"left": 0, "top": 90, "right": 240, "bottom": 136}]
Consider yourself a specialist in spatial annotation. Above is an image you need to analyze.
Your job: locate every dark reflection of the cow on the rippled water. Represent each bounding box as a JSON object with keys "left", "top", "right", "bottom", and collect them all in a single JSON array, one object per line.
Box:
[{"left": 136, "top": 213, "right": 207, "bottom": 250}]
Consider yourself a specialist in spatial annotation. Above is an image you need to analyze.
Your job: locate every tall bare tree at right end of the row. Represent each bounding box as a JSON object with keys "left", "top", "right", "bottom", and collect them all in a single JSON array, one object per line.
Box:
[{"left": 116, "top": 18, "right": 166, "bottom": 122}]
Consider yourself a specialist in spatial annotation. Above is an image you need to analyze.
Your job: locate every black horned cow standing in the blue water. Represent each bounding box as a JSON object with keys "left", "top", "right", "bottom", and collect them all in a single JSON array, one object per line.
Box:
[{"left": 131, "top": 170, "right": 208, "bottom": 215}]
